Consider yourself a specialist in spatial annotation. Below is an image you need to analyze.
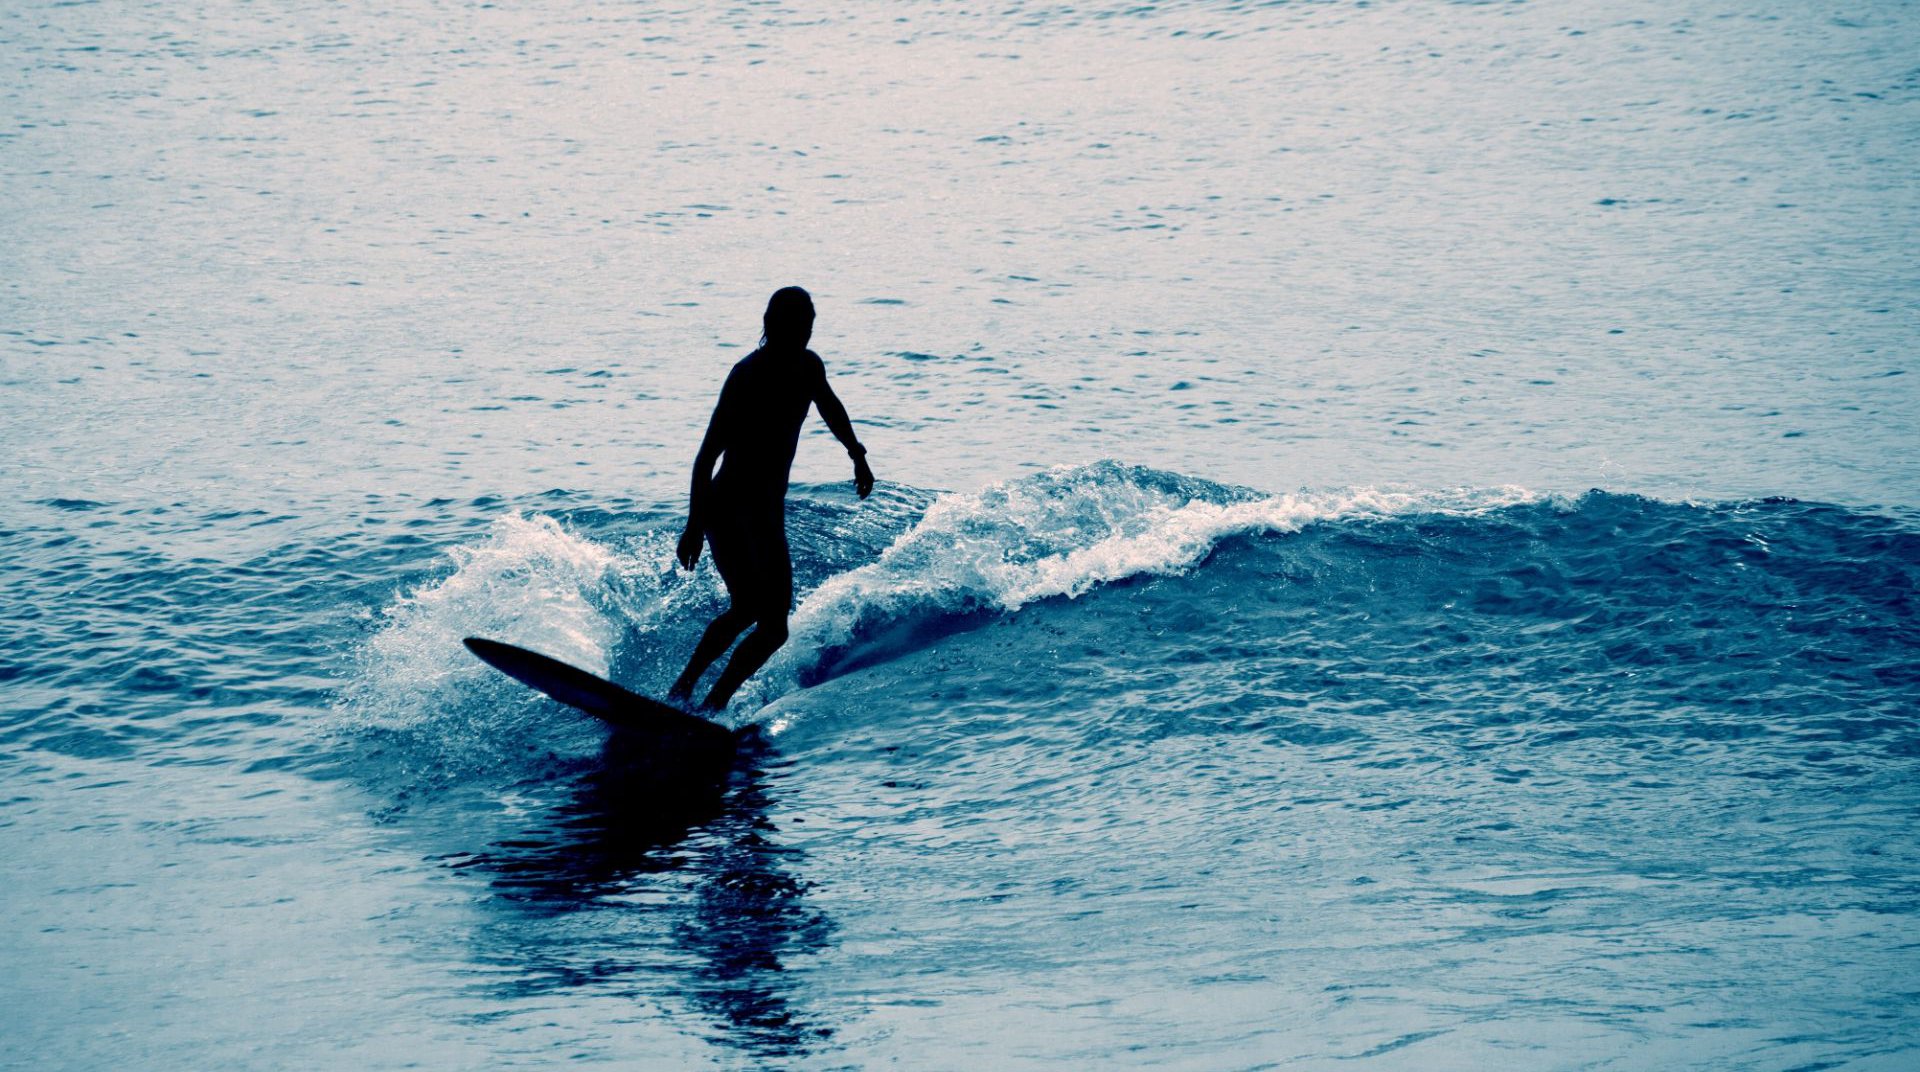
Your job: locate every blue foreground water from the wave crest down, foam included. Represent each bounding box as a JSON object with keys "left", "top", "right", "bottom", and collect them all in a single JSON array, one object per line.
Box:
[{"left": 4, "top": 463, "right": 1920, "bottom": 1066}]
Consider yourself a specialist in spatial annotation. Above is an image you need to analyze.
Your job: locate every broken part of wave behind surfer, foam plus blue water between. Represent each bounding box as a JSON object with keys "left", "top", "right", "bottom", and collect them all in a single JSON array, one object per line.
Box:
[{"left": 337, "top": 461, "right": 1534, "bottom": 763}]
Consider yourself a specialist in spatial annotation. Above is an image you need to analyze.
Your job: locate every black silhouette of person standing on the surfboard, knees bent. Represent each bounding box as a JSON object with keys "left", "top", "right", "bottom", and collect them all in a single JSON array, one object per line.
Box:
[{"left": 668, "top": 286, "right": 874, "bottom": 711}]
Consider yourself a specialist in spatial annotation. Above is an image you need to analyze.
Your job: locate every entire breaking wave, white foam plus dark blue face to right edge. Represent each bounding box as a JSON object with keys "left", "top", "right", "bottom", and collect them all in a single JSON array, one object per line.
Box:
[{"left": 348, "top": 463, "right": 1920, "bottom": 768}]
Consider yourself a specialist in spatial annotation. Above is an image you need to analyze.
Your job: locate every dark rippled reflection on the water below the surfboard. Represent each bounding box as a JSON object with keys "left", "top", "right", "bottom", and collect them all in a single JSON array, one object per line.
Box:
[{"left": 449, "top": 732, "right": 833, "bottom": 1060}]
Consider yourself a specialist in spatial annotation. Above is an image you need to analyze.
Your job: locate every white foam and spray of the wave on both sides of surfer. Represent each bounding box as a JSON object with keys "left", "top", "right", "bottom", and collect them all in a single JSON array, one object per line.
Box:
[{"left": 344, "top": 461, "right": 1540, "bottom": 730}]
